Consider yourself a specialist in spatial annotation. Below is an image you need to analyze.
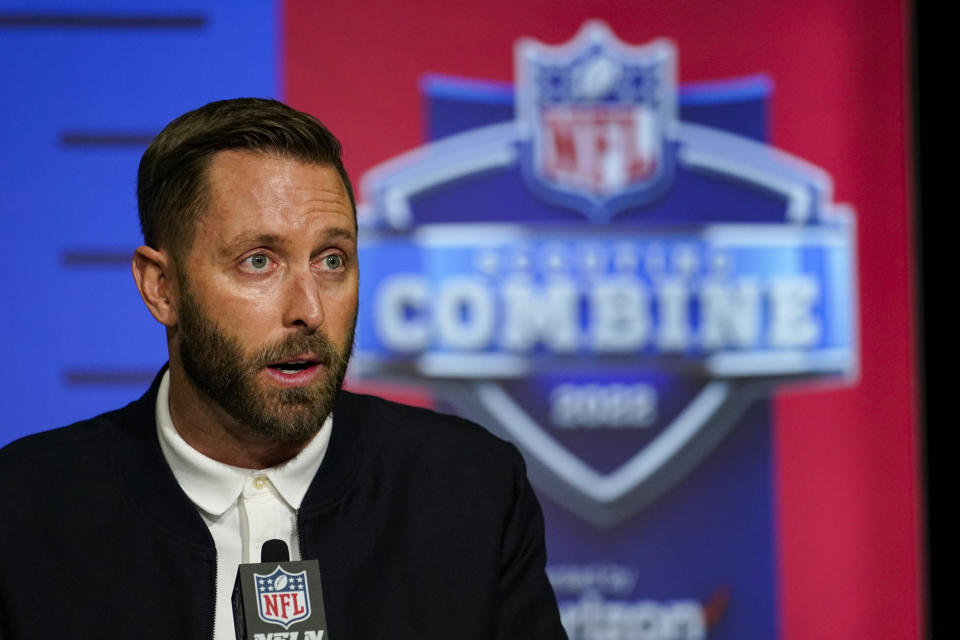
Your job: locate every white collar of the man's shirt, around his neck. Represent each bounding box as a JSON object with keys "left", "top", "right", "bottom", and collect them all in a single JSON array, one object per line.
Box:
[{"left": 155, "top": 370, "right": 333, "bottom": 516}]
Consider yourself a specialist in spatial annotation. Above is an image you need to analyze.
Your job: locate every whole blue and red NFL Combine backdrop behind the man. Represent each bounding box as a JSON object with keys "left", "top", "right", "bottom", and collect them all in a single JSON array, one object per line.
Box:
[{"left": 0, "top": 0, "right": 922, "bottom": 639}]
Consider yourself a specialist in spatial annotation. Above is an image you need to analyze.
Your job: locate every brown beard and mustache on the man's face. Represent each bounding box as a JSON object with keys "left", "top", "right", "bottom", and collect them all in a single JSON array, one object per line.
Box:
[{"left": 178, "top": 279, "right": 356, "bottom": 443}]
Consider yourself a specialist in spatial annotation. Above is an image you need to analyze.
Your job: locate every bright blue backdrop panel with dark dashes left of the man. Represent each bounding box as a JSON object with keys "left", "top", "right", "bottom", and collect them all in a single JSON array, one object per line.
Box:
[{"left": 0, "top": 0, "right": 279, "bottom": 445}]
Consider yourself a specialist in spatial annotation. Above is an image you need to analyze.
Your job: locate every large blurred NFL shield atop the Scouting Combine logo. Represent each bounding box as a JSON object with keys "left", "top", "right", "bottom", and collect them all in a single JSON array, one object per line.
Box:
[{"left": 516, "top": 22, "right": 676, "bottom": 222}]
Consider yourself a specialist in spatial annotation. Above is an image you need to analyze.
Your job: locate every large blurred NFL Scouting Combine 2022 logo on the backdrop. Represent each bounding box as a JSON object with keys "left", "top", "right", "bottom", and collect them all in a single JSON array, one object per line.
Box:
[{"left": 352, "top": 22, "right": 857, "bottom": 527}]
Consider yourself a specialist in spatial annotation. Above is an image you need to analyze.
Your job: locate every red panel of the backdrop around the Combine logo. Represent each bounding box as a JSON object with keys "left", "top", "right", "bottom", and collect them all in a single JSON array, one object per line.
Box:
[{"left": 281, "top": 0, "right": 922, "bottom": 640}]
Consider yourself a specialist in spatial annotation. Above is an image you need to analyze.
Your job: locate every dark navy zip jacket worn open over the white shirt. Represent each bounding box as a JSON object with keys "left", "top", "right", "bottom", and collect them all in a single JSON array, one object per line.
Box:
[{"left": 0, "top": 377, "right": 565, "bottom": 640}]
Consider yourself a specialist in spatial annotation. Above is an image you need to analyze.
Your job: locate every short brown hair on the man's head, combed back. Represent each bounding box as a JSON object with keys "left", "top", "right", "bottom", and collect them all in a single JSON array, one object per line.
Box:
[{"left": 137, "top": 98, "right": 357, "bottom": 257}]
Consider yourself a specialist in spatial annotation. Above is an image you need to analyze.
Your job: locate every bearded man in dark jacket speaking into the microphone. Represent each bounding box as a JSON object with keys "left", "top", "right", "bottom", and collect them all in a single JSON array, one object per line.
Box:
[{"left": 0, "top": 99, "right": 564, "bottom": 640}]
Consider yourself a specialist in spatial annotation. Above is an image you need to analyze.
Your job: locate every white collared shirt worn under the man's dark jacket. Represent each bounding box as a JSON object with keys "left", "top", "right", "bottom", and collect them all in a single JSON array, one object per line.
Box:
[{"left": 156, "top": 371, "right": 333, "bottom": 640}]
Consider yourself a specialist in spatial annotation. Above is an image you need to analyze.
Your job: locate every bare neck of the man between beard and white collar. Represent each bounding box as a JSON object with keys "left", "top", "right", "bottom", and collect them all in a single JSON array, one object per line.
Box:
[{"left": 170, "top": 363, "right": 310, "bottom": 469}]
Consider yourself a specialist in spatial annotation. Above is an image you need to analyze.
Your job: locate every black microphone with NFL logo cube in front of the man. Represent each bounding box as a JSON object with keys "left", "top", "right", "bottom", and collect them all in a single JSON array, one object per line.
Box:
[{"left": 231, "top": 540, "right": 330, "bottom": 640}]
